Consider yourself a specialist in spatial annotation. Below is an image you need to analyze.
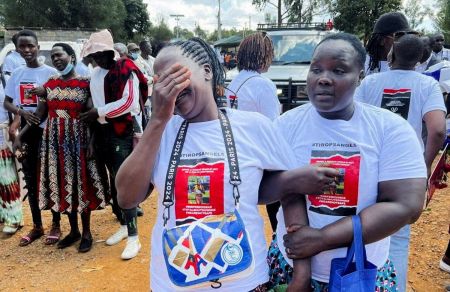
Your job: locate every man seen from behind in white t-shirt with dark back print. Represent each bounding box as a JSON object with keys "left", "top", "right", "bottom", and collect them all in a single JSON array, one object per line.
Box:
[{"left": 355, "top": 35, "right": 446, "bottom": 291}]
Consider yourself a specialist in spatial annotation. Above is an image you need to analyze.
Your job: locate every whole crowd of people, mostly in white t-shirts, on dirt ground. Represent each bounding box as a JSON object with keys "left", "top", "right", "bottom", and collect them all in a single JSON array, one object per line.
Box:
[{"left": 0, "top": 12, "right": 450, "bottom": 291}]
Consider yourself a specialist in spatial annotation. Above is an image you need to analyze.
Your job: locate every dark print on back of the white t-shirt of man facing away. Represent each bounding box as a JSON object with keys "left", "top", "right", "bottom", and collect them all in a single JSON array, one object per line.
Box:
[{"left": 381, "top": 88, "right": 411, "bottom": 120}]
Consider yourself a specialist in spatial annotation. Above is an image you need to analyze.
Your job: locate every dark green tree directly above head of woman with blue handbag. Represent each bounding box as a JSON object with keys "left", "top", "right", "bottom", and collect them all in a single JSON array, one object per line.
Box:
[{"left": 327, "top": 0, "right": 401, "bottom": 42}]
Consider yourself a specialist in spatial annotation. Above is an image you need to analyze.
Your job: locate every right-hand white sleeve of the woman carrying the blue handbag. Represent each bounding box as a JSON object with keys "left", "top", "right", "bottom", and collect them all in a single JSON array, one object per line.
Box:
[{"left": 378, "top": 113, "right": 427, "bottom": 181}]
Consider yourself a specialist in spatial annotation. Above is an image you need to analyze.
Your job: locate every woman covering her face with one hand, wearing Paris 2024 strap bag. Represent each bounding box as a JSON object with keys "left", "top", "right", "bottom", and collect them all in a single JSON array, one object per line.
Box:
[{"left": 116, "top": 38, "right": 338, "bottom": 291}]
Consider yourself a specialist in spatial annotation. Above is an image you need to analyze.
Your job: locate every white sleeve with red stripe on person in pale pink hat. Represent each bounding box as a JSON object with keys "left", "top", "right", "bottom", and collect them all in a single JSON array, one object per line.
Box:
[{"left": 97, "top": 73, "right": 139, "bottom": 118}]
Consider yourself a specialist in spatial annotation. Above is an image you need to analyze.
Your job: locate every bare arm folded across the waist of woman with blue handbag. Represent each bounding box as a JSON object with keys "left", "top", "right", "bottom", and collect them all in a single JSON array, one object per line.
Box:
[{"left": 284, "top": 178, "right": 426, "bottom": 258}]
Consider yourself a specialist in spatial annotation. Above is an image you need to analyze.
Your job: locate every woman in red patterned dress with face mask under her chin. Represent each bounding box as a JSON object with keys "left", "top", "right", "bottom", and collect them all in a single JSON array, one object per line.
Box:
[{"left": 14, "top": 43, "right": 107, "bottom": 252}]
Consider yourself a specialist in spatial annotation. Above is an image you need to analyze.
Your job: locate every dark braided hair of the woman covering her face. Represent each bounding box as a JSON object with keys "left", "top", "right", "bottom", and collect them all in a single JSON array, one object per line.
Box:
[{"left": 168, "top": 37, "right": 225, "bottom": 102}]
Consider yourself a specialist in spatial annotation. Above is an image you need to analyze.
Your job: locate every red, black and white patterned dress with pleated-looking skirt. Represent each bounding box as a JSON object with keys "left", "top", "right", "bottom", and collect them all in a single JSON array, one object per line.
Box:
[{"left": 39, "top": 77, "right": 108, "bottom": 213}]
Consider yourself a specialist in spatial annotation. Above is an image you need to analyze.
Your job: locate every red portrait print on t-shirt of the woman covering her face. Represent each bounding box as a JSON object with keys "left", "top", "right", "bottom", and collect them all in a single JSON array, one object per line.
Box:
[{"left": 175, "top": 157, "right": 225, "bottom": 225}]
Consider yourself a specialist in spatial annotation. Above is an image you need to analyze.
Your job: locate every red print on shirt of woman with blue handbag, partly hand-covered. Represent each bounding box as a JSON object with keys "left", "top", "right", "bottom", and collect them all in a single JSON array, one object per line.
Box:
[{"left": 308, "top": 147, "right": 361, "bottom": 216}]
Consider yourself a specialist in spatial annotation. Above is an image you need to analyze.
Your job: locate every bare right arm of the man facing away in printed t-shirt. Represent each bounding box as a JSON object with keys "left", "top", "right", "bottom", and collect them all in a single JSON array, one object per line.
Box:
[{"left": 423, "top": 110, "right": 446, "bottom": 176}]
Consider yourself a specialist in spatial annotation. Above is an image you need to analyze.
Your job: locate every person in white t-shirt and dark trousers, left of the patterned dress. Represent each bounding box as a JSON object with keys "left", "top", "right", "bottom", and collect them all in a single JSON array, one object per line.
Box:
[{"left": 4, "top": 30, "right": 61, "bottom": 246}]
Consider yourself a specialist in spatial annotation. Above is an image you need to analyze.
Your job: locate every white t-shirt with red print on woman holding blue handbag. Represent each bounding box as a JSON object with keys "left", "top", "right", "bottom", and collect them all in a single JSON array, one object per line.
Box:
[{"left": 275, "top": 102, "right": 426, "bottom": 282}]
